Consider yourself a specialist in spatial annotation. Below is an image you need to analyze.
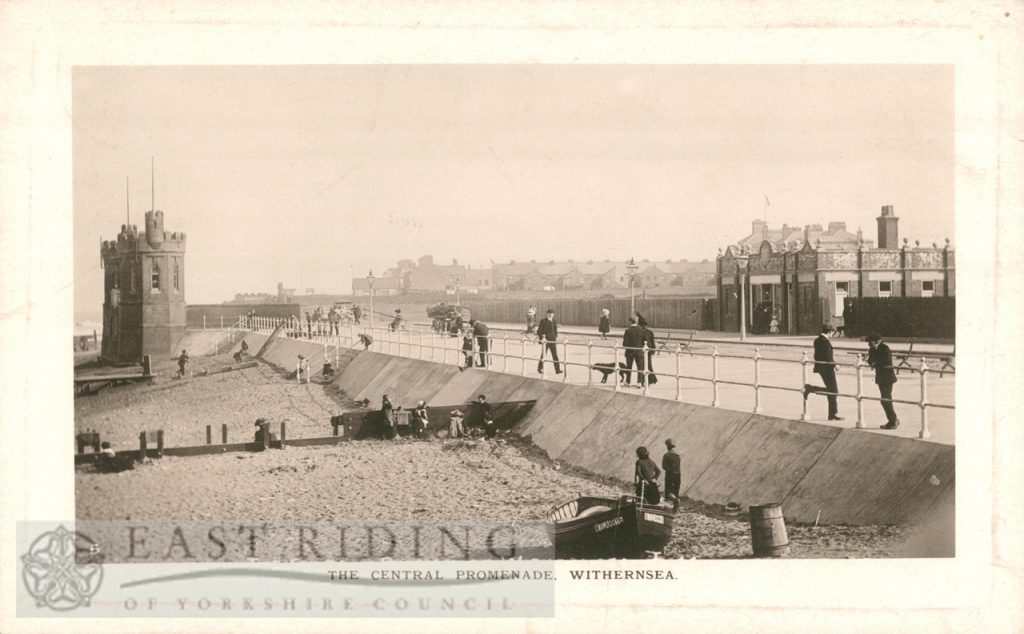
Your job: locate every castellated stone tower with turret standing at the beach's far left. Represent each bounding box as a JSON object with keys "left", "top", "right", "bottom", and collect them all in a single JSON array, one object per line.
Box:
[{"left": 99, "top": 211, "right": 185, "bottom": 363}]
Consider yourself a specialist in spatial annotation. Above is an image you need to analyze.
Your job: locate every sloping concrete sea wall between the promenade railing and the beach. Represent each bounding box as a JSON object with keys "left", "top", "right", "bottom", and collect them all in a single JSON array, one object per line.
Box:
[{"left": 232, "top": 333, "right": 955, "bottom": 525}]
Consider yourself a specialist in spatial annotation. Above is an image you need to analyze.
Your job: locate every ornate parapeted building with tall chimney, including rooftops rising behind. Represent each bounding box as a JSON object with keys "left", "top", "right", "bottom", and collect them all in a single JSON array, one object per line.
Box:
[{"left": 717, "top": 205, "right": 956, "bottom": 334}]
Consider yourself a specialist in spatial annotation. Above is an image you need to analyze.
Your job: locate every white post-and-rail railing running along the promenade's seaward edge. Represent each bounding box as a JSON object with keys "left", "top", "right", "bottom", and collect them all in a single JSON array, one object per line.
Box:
[{"left": 238, "top": 315, "right": 955, "bottom": 438}]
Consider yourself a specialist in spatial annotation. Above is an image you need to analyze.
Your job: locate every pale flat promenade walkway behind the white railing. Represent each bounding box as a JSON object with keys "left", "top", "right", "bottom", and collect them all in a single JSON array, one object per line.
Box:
[{"left": 245, "top": 323, "right": 955, "bottom": 445}]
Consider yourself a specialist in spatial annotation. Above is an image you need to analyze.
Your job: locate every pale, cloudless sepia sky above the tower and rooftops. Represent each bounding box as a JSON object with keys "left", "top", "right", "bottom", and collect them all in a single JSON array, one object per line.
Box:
[{"left": 72, "top": 65, "right": 954, "bottom": 316}]
